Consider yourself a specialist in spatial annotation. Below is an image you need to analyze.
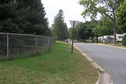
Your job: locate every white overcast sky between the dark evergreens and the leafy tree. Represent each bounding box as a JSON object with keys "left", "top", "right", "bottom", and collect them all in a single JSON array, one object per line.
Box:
[{"left": 41, "top": 0, "right": 89, "bottom": 28}]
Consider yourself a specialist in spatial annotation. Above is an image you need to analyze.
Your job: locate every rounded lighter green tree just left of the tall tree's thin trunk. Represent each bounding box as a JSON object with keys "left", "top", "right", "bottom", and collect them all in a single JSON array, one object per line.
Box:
[{"left": 92, "top": 16, "right": 113, "bottom": 36}]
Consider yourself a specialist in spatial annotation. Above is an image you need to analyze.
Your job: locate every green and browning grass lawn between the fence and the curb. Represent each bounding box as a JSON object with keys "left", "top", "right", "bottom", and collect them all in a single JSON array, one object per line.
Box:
[{"left": 0, "top": 42, "right": 98, "bottom": 84}]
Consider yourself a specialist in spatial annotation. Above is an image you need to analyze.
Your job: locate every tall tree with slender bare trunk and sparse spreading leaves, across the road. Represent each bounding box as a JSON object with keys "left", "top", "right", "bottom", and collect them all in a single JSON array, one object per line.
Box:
[{"left": 80, "top": 0, "right": 123, "bottom": 44}]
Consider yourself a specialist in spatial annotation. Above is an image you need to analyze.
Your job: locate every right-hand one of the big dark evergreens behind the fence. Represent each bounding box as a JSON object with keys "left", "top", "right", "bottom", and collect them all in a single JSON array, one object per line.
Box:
[{"left": 17, "top": 0, "right": 50, "bottom": 35}]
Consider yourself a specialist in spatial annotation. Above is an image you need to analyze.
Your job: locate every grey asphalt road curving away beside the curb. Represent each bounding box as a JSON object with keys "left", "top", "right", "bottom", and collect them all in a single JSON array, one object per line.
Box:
[{"left": 75, "top": 43, "right": 126, "bottom": 84}]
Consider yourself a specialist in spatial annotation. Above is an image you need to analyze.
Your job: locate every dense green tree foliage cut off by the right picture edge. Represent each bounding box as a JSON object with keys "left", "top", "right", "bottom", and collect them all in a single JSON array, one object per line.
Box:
[{"left": 117, "top": 1, "right": 126, "bottom": 33}]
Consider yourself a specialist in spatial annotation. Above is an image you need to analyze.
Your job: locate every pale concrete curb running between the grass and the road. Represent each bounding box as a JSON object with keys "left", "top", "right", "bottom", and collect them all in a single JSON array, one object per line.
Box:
[{"left": 74, "top": 45, "right": 113, "bottom": 84}]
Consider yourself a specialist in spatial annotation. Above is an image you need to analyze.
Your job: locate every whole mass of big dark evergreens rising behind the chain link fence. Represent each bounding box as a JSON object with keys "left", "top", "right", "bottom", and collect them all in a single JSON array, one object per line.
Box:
[{"left": 0, "top": 0, "right": 50, "bottom": 35}]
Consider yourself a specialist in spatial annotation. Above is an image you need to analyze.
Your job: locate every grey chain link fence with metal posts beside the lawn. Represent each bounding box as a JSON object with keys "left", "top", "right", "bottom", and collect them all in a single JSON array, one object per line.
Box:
[{"left": 0, "top": 33, "right": 55, "bottom": 61}]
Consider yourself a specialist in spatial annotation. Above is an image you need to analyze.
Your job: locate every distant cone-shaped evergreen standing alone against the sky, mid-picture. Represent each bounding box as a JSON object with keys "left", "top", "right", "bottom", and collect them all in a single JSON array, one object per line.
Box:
[{"left": 52, "top": 10, "right": 69, "bottom": 41}]
